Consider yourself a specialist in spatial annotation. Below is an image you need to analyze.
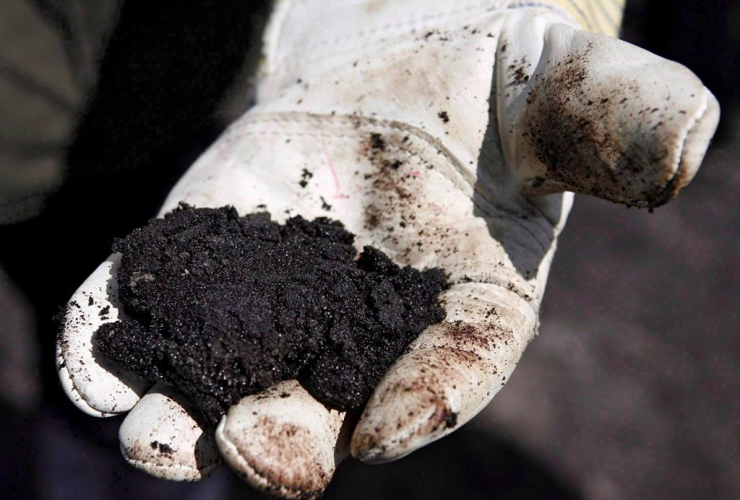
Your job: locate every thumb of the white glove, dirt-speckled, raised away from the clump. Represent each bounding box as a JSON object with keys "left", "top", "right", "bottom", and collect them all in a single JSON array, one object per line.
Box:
[{"left": 497, "top": 21, "right": 720, "bottom": 207}]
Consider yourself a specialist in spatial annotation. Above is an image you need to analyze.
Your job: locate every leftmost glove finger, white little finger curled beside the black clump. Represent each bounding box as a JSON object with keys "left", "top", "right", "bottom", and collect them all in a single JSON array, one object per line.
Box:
[{"left": 56, "top": 254, "right": 151, "bottom": 417}]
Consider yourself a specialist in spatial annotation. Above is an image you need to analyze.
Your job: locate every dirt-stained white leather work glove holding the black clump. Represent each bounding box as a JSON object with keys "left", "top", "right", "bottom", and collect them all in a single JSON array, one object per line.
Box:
[{"left": 58, "top": 0, "right": 719, "bottom": 498}]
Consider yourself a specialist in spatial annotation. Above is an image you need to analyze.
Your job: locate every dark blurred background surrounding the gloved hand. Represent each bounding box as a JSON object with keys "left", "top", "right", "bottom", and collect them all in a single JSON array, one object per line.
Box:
[{"left": 0, "top": 0, "right": 740, "bottom": 500}]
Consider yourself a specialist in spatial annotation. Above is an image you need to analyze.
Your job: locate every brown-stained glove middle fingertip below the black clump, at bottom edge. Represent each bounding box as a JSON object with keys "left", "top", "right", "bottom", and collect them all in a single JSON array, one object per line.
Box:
[{"left": 216, "top": 380, "right": 347, "bottom": 499}]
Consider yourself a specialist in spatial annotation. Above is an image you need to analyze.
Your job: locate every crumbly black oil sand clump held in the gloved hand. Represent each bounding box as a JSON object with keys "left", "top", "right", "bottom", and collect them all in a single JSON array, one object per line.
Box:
[{"left": 95, "top": 205, "right": 447, "bottom": 423}]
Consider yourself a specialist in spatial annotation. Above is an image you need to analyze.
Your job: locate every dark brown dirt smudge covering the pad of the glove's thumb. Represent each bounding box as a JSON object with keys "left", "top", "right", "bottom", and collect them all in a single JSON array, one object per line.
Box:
[{"left": 514, "top": 44, "right": 675, "bottom": 207}]
